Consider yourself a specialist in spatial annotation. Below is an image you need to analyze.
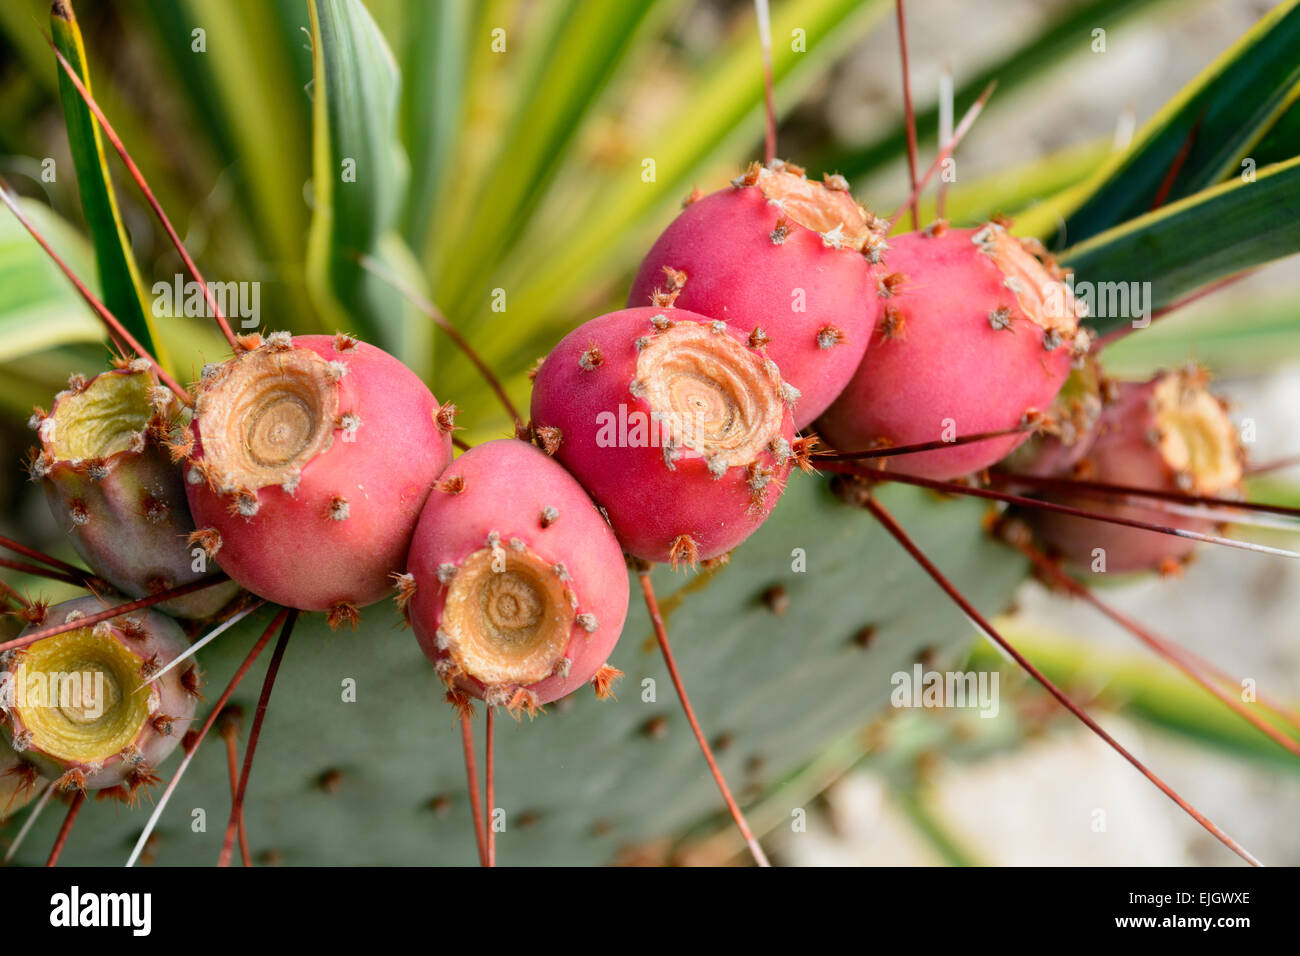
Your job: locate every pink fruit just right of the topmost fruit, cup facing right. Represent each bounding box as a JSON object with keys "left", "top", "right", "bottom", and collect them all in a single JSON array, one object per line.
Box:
[{"left": 818, "top": 222, "right": 1088, "bottom": 480}]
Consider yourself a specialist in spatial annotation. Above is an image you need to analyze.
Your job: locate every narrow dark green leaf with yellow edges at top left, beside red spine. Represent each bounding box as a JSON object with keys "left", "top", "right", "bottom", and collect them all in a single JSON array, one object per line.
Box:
[{"left": 49, "top": 0, "right": 168, "bottom": 365}]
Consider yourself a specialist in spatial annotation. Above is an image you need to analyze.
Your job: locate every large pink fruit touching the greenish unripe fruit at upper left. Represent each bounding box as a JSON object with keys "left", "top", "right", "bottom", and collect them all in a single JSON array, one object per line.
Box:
[{"left": 186, "top": 333, "right": 455, "bottom": 626}]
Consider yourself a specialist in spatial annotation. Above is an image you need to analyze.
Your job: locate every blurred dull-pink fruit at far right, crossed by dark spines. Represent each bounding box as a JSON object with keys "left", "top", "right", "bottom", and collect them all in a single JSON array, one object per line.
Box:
[{"left": 1024, "top": 368, "right": 1244, "bottom": 574}]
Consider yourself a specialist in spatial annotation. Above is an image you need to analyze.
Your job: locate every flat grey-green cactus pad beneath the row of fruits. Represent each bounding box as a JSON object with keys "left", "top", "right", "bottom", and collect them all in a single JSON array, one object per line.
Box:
[{"left": 7, "top": 473, "right": 1024, "bottom": 865}]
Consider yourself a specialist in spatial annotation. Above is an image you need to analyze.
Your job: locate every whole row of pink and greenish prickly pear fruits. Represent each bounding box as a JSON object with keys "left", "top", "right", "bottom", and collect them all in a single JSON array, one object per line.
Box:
[{"left": 4, "top": 145, "right": 1242, "bottom": 842}]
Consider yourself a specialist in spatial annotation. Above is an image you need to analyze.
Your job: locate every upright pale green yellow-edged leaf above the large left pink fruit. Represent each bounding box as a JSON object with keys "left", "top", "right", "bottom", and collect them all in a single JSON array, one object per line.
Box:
[{"left": 307, "top": 0, "right": 432, "bottom": 375}]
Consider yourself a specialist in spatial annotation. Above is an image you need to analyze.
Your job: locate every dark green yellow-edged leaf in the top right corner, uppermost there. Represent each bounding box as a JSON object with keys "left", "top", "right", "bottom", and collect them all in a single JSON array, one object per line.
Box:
[{"left": 1063, "top": 0, "right": 1300, "bottom": 243}]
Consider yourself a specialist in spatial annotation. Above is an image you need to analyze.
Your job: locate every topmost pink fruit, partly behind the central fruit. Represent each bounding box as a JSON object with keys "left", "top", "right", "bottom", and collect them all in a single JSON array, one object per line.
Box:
[{"left": 628, "top": 161, "right": 889, "bottom": 428}]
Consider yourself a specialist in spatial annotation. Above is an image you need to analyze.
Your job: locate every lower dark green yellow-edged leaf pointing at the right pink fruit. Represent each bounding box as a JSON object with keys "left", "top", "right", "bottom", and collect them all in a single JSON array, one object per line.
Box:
[{"left": 1061, "top": 156, "right": 1300, "bottom": 333}]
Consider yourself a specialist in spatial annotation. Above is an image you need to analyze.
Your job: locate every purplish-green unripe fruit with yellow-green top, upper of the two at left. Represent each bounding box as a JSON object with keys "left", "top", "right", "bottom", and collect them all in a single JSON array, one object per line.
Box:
[{"left": 30, "top": 360, "right": 239, "bottom": 618}]
